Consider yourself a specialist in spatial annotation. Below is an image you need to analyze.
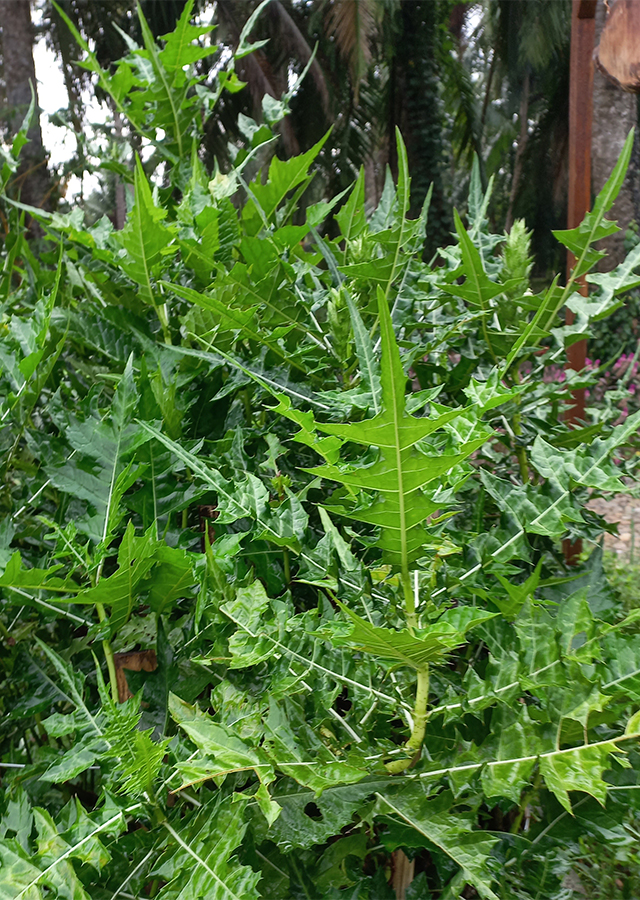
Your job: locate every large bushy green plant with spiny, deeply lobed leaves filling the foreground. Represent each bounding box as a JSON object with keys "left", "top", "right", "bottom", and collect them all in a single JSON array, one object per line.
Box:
[{"left": 0, "top": 5, "right": 640, "bottom": 900}]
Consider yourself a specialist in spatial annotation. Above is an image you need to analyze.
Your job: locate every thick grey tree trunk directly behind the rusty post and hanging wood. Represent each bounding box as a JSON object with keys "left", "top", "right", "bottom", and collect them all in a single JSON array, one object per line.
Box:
[{"left": 591, "top": 3, "right": 639, "bottom": 271}]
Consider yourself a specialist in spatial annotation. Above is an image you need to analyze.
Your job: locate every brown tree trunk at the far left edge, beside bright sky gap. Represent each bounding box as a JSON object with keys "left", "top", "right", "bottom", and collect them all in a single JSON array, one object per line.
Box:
[{"left": 0, "top": 0, "right": 52, "bottom": 223}]
